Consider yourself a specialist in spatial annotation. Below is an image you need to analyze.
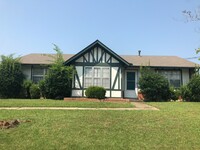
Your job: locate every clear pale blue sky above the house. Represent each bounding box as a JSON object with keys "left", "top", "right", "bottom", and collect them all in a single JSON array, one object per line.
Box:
[{"left": 0, "top": 0, "right": 200, "bottom": 63}]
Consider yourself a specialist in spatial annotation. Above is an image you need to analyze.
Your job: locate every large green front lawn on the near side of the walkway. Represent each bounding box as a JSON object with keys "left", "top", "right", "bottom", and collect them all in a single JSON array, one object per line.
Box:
[{"left": 0, "top": 102, "right": 200, "bottom": 150}]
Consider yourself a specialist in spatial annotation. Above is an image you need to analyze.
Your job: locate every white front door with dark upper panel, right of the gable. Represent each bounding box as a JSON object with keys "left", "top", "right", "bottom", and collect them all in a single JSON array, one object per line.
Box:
[{"left": 124, "top": 71, "right": 137, "bottom": 98}]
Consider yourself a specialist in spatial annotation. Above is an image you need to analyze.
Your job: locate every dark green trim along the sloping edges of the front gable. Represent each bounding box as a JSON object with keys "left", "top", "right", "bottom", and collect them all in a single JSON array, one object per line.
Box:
[{"left": 65, "top": 40, "right": 131, "bottom": 66}]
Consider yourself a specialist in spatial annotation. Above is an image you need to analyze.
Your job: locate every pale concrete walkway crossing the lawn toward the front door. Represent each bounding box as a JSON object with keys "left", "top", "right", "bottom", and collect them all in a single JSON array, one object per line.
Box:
[{"left": 0, "top": 102, "right": 159, "bottom": 110}]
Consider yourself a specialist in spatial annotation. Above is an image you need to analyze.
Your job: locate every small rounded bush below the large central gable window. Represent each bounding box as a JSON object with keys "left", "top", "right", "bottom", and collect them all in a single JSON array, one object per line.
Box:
[{"left": 85, "top": 86, "right": 106, "bottom": 99}]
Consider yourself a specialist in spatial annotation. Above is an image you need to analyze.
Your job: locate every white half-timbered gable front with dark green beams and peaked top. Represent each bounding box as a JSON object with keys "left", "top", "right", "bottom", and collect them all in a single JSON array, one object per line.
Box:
[{"left": 65, "top": 40, "right": 130, "bottom": 97}]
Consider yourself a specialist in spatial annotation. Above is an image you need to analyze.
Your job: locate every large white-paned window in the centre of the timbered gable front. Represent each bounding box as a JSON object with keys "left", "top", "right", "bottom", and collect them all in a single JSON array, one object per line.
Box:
[{"left": 84, "top": 67, "right": 110, "bottom": 88}]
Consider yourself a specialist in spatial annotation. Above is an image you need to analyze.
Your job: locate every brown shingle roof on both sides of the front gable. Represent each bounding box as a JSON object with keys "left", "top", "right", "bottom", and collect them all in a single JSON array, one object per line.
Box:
[{"left": 21, "top": 54, "right": 195, "bottom": 68}]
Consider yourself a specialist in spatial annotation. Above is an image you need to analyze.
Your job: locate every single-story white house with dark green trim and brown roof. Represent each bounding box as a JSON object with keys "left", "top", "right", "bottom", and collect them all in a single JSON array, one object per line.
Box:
[{"left": 21, "top": 40, "right": 195, "bottom": 98}]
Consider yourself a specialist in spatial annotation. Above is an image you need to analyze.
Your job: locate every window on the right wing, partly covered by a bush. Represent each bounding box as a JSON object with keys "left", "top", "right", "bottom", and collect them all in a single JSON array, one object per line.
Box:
[{"left": 158, "top": 70, "right": 181, "bottom": 88}]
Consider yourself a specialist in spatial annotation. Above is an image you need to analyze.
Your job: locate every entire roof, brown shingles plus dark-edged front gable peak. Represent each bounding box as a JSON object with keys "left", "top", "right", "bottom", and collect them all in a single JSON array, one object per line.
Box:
[{"left": 21, "top": 40, "right": 195, "bottom": 68}]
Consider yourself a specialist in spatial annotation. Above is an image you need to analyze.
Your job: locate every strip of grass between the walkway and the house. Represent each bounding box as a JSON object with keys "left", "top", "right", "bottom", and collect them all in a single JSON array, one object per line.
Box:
[{"left": 0, "top": 99, "right": 133, "bottom": 108}]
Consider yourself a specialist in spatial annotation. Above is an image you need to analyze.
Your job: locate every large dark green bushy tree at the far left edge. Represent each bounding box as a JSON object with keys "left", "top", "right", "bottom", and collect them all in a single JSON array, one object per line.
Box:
[{"left": 0, "top": 55, "right": 23, "bottom": 98}]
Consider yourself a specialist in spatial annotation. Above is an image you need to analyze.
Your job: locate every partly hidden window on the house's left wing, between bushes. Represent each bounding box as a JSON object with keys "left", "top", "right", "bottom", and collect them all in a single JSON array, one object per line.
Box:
[{"left": 32, "top": 68, "right": 47, "bottom": 83}]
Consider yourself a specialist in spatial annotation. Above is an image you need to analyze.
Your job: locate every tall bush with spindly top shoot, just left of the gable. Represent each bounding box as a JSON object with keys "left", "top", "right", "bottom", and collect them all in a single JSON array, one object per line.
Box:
[{"left": 43, "top": 44, "right": 74, "bottom": 99}]
